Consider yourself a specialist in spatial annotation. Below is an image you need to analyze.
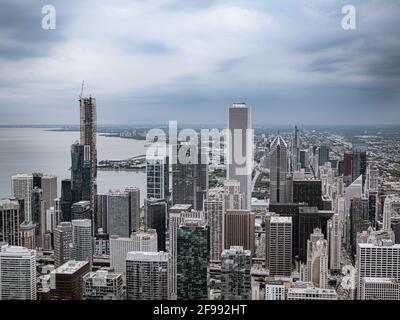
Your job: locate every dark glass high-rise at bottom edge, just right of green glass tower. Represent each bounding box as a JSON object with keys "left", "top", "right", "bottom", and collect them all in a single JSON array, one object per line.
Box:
[{"left": 221, "top": 247, "right": 251, "bottom": 300}]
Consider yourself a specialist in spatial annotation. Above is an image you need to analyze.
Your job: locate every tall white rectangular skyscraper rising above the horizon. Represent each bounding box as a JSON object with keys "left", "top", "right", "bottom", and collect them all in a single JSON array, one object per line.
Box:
[{"left": 227, "top": 103, "right": 253, "bottom": 210}]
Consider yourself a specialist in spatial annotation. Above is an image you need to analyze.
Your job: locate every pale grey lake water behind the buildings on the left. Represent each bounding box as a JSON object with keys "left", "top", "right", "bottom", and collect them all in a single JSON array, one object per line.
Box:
[{"left": 0, "top": 128, "right": 146, "bottom": 203}]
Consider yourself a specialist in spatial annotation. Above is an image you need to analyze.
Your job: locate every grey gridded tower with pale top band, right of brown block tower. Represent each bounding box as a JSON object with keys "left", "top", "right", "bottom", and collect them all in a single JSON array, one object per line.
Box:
[{"left": 265, "top": 214, "right": 292, "bottom": 276}]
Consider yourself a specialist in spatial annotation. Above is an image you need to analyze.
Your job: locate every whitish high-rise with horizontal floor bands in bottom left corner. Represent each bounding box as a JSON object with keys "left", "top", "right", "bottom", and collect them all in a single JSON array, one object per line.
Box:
[{"left": 0, "top": 245, "right": 36, "bottom": 300}]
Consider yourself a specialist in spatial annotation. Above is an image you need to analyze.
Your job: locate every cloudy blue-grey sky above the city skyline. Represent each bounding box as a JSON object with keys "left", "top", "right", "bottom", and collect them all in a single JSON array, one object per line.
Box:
[{"left": 0, "top": 0, "right": 400, "bottom": 125}]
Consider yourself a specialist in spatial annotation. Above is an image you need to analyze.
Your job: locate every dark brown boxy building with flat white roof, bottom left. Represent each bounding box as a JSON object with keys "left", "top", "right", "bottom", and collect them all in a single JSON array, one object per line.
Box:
[{"left": 50, "top": 260, "right": 90, "bottom": 300}]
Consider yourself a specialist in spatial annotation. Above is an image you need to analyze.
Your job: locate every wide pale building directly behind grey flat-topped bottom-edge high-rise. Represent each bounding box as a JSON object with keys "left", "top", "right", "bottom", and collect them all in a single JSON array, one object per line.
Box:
[{"left": 110, "top": 229, "right": 157, "bottom": 273}]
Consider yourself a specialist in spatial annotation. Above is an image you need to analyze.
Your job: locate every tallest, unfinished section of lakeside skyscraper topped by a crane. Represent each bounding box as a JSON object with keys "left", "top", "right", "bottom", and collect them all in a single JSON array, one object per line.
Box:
[{"left": 79, "top": 96, "right": 97, "bottom": 210}]
